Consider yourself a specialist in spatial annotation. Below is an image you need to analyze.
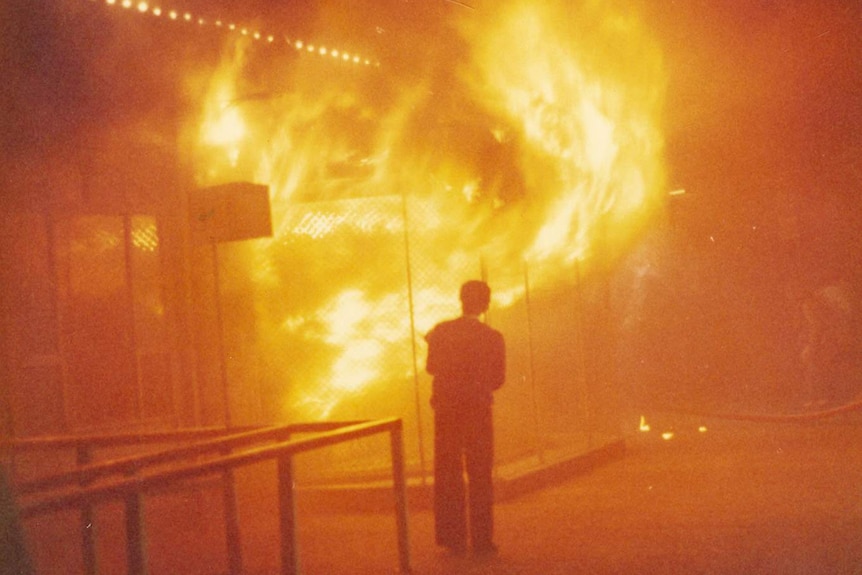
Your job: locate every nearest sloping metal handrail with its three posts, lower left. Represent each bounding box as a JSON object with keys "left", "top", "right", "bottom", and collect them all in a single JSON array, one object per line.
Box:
[{"left": 21, "top": 418, "right": 410, "bottom": 575}]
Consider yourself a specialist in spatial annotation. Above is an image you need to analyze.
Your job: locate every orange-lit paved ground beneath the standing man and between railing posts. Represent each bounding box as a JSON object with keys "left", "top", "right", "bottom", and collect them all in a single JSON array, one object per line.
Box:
[{"left": 18, "top": 411, "right": 862, "bottom": 575}]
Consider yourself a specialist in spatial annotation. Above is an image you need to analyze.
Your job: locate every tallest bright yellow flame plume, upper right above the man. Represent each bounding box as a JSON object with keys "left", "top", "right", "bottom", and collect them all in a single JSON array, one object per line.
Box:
[{"left": 460, "top": 2, "right": 662, "bottom": 263}]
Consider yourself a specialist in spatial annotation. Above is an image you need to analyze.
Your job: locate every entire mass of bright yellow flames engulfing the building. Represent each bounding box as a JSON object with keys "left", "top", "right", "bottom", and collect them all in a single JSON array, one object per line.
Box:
[{"left": 189, "top": 1, "right": 663, "bottom": 424}]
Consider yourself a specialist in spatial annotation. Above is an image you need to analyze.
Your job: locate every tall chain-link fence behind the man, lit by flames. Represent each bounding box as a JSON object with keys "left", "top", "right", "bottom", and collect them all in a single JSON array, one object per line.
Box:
[{"left": 218, "top": 192, "right": 620, "bottom": 481}]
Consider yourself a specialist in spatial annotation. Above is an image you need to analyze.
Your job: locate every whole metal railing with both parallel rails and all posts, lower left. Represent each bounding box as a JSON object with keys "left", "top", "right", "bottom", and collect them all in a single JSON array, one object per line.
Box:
[{"left": 20, "top": 418, "right": 411, "bottom": 575}]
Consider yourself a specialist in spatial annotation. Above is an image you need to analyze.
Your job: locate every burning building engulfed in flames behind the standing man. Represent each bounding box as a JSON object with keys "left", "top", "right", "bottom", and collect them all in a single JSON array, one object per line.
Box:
[{"left": 0, "top": 0, "right": 860, "bottom": 486}]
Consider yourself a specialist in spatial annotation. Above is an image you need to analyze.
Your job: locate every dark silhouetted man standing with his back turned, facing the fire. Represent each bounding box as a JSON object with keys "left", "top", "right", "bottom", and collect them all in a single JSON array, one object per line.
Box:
[{"left": 426, "top": 280, "right": 506, "bottom": 554}]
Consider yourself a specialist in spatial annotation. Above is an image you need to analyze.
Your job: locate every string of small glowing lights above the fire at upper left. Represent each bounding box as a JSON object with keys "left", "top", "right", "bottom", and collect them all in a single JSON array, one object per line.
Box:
[{"left": 89, "top": 0, "right": 380, "bottom": 67}]
